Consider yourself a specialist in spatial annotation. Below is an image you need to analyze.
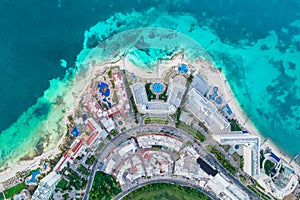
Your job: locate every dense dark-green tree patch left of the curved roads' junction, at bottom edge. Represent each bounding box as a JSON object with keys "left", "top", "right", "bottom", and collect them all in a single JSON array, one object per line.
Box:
[{"left": 90, "top": 172, "right": 122, "bottom": 200}]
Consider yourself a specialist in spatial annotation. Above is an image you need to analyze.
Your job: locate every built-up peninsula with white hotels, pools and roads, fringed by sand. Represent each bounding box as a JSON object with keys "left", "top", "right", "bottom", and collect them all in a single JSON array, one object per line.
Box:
[{"left": 0, "top": 51, "right": 300, "bottom": 200}]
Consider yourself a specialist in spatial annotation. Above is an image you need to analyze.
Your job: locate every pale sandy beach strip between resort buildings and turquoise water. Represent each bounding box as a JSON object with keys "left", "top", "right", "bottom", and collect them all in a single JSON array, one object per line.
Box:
[{"left": 0, "top": 54, "right": 300, "bottom": 189}]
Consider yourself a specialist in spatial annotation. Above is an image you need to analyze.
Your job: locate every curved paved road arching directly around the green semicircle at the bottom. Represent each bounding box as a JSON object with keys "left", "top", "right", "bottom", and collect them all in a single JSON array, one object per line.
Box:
[{"left": 113, "top": 177, "right": 218, "bottom": 200}]
